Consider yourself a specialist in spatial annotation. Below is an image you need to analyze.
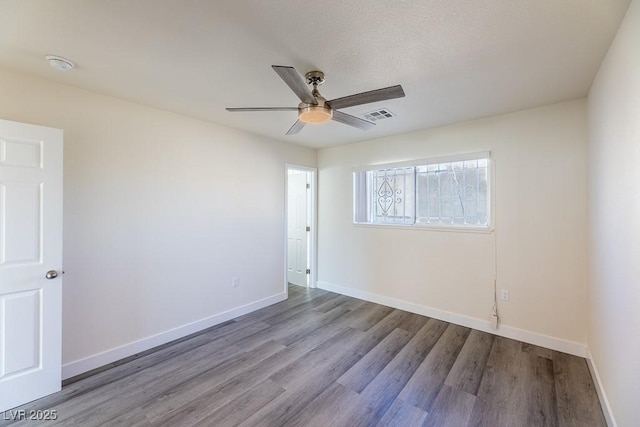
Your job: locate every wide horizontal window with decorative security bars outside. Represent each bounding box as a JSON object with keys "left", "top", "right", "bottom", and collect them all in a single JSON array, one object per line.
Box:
[{"left": 353, "top": 153, "right": 490, "bottom": 229}]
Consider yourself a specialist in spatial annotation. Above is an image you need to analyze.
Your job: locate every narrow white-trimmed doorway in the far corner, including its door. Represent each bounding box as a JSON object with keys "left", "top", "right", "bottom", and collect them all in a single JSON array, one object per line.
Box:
[{"left": 285, "top": 165, "right": 316, "bottom": 288}]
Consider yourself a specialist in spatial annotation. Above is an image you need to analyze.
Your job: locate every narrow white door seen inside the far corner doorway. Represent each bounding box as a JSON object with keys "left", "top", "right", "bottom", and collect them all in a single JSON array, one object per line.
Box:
[{"left": 287, "top": 170, "right": 308, "bottom": 286}]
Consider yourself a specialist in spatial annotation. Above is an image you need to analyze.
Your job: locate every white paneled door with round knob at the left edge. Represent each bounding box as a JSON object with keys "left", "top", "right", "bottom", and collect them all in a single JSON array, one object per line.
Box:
[{"left": 0, "top": 120, "right": 62, "bottom": 412}]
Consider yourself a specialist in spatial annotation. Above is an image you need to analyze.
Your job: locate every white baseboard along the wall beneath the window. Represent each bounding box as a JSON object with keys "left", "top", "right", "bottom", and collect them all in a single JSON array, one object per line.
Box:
[{"left": 318, "top": 281, "right": 587, "bottom": 357}]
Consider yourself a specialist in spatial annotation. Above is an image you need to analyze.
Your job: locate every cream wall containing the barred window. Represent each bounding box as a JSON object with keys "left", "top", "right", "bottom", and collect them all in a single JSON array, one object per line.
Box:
[{"left": 318, "top": 99, "right": 587, "bottom": 354}]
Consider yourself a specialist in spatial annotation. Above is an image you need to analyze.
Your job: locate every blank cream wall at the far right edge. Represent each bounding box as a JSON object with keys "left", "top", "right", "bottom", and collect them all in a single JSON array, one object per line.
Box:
[{"left": 588, "top": 0, "right": 640, "bottom": 426}]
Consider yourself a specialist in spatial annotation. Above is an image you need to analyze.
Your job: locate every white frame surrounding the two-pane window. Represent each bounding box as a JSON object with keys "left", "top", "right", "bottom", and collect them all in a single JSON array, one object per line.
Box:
[{"left": 351, "top": 151, "right": 495, "bottom": 233}]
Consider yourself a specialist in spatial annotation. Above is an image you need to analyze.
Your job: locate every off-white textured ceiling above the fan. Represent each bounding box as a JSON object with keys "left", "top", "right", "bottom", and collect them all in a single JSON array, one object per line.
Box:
[{"left": 0, "top": 0, "right": 630, "bottom": 148}]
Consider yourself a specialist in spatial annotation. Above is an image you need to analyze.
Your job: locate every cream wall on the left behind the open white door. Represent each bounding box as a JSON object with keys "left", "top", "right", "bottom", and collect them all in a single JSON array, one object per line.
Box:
[{"left": 0, "top": 67, "right": 316, "bottom": 376}]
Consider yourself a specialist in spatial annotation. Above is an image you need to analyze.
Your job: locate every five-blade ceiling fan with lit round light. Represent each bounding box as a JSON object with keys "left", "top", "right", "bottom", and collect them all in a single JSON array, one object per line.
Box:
[{"left": 227, "top": 65, "right": 404, "bottom": 135}]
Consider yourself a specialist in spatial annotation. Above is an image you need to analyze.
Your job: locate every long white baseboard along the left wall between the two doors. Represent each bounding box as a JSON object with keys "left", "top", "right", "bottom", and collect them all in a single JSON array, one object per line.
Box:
[{"left": 62, "top": 292, "right": 287, "bottom": 380}]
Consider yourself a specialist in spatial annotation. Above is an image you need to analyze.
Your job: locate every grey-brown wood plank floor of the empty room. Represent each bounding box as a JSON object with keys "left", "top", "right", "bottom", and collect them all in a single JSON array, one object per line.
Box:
[{"left": 0, "top": 286, "right": 606, "bottom": 427}]
